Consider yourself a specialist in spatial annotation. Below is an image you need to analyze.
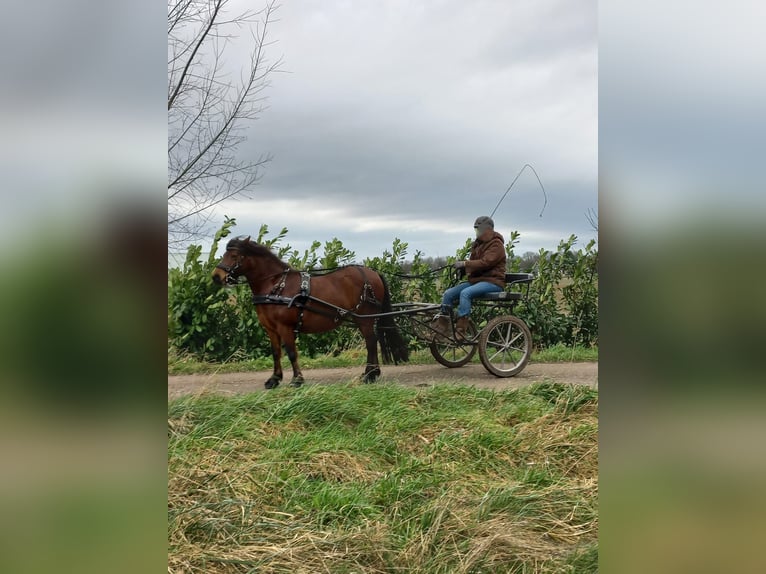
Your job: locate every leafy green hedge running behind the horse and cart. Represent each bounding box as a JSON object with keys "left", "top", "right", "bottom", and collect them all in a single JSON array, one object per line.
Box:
[{"left": 168, "top": 218, "right": 598, "bottom": 361}]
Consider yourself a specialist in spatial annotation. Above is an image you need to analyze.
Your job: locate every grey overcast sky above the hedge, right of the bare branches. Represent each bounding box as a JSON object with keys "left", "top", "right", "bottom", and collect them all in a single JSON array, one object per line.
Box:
[{"left": 213, "top": 0, "right": 598, "bottom": 261}]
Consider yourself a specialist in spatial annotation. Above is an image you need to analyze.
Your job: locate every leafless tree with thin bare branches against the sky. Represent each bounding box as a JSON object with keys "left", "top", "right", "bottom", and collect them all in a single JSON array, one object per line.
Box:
[{"left": 168, "top": 0, "right": 281, "bottom": 244}]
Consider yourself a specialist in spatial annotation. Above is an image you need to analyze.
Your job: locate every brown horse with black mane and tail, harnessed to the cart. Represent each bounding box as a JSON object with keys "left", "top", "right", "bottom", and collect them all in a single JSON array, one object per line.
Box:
[{"left": 213, "top": 236, "right": 409, "bottom": 389}]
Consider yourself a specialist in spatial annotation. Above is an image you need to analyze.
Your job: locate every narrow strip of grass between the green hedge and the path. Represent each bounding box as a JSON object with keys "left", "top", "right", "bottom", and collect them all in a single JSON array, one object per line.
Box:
[{"left": 168, "top": 345, "right": 598, "bottom": 375}]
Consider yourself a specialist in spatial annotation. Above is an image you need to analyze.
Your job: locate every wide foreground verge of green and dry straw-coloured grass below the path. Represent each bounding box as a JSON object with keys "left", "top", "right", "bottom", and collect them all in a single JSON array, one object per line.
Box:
[{"left": 168, "top": 383, "right": 598, "bottom": 574}]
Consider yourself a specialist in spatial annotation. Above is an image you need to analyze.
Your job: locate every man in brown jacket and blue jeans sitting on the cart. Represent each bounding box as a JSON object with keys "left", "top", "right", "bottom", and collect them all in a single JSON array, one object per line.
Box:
[{"left": 431, "top": 215, "right": 506, "bottom": 339}]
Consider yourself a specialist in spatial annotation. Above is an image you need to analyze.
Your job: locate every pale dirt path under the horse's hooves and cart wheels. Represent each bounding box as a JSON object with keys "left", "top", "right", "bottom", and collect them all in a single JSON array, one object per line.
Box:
[{"left": 168, "top": 363, "right": 598, "bottom": 399}]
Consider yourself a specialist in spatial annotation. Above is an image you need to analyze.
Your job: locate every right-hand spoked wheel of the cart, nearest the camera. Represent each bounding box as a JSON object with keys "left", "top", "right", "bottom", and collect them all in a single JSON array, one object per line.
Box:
[{"left": 479, "top": 315, "right": 532, "bottom": 377}]
